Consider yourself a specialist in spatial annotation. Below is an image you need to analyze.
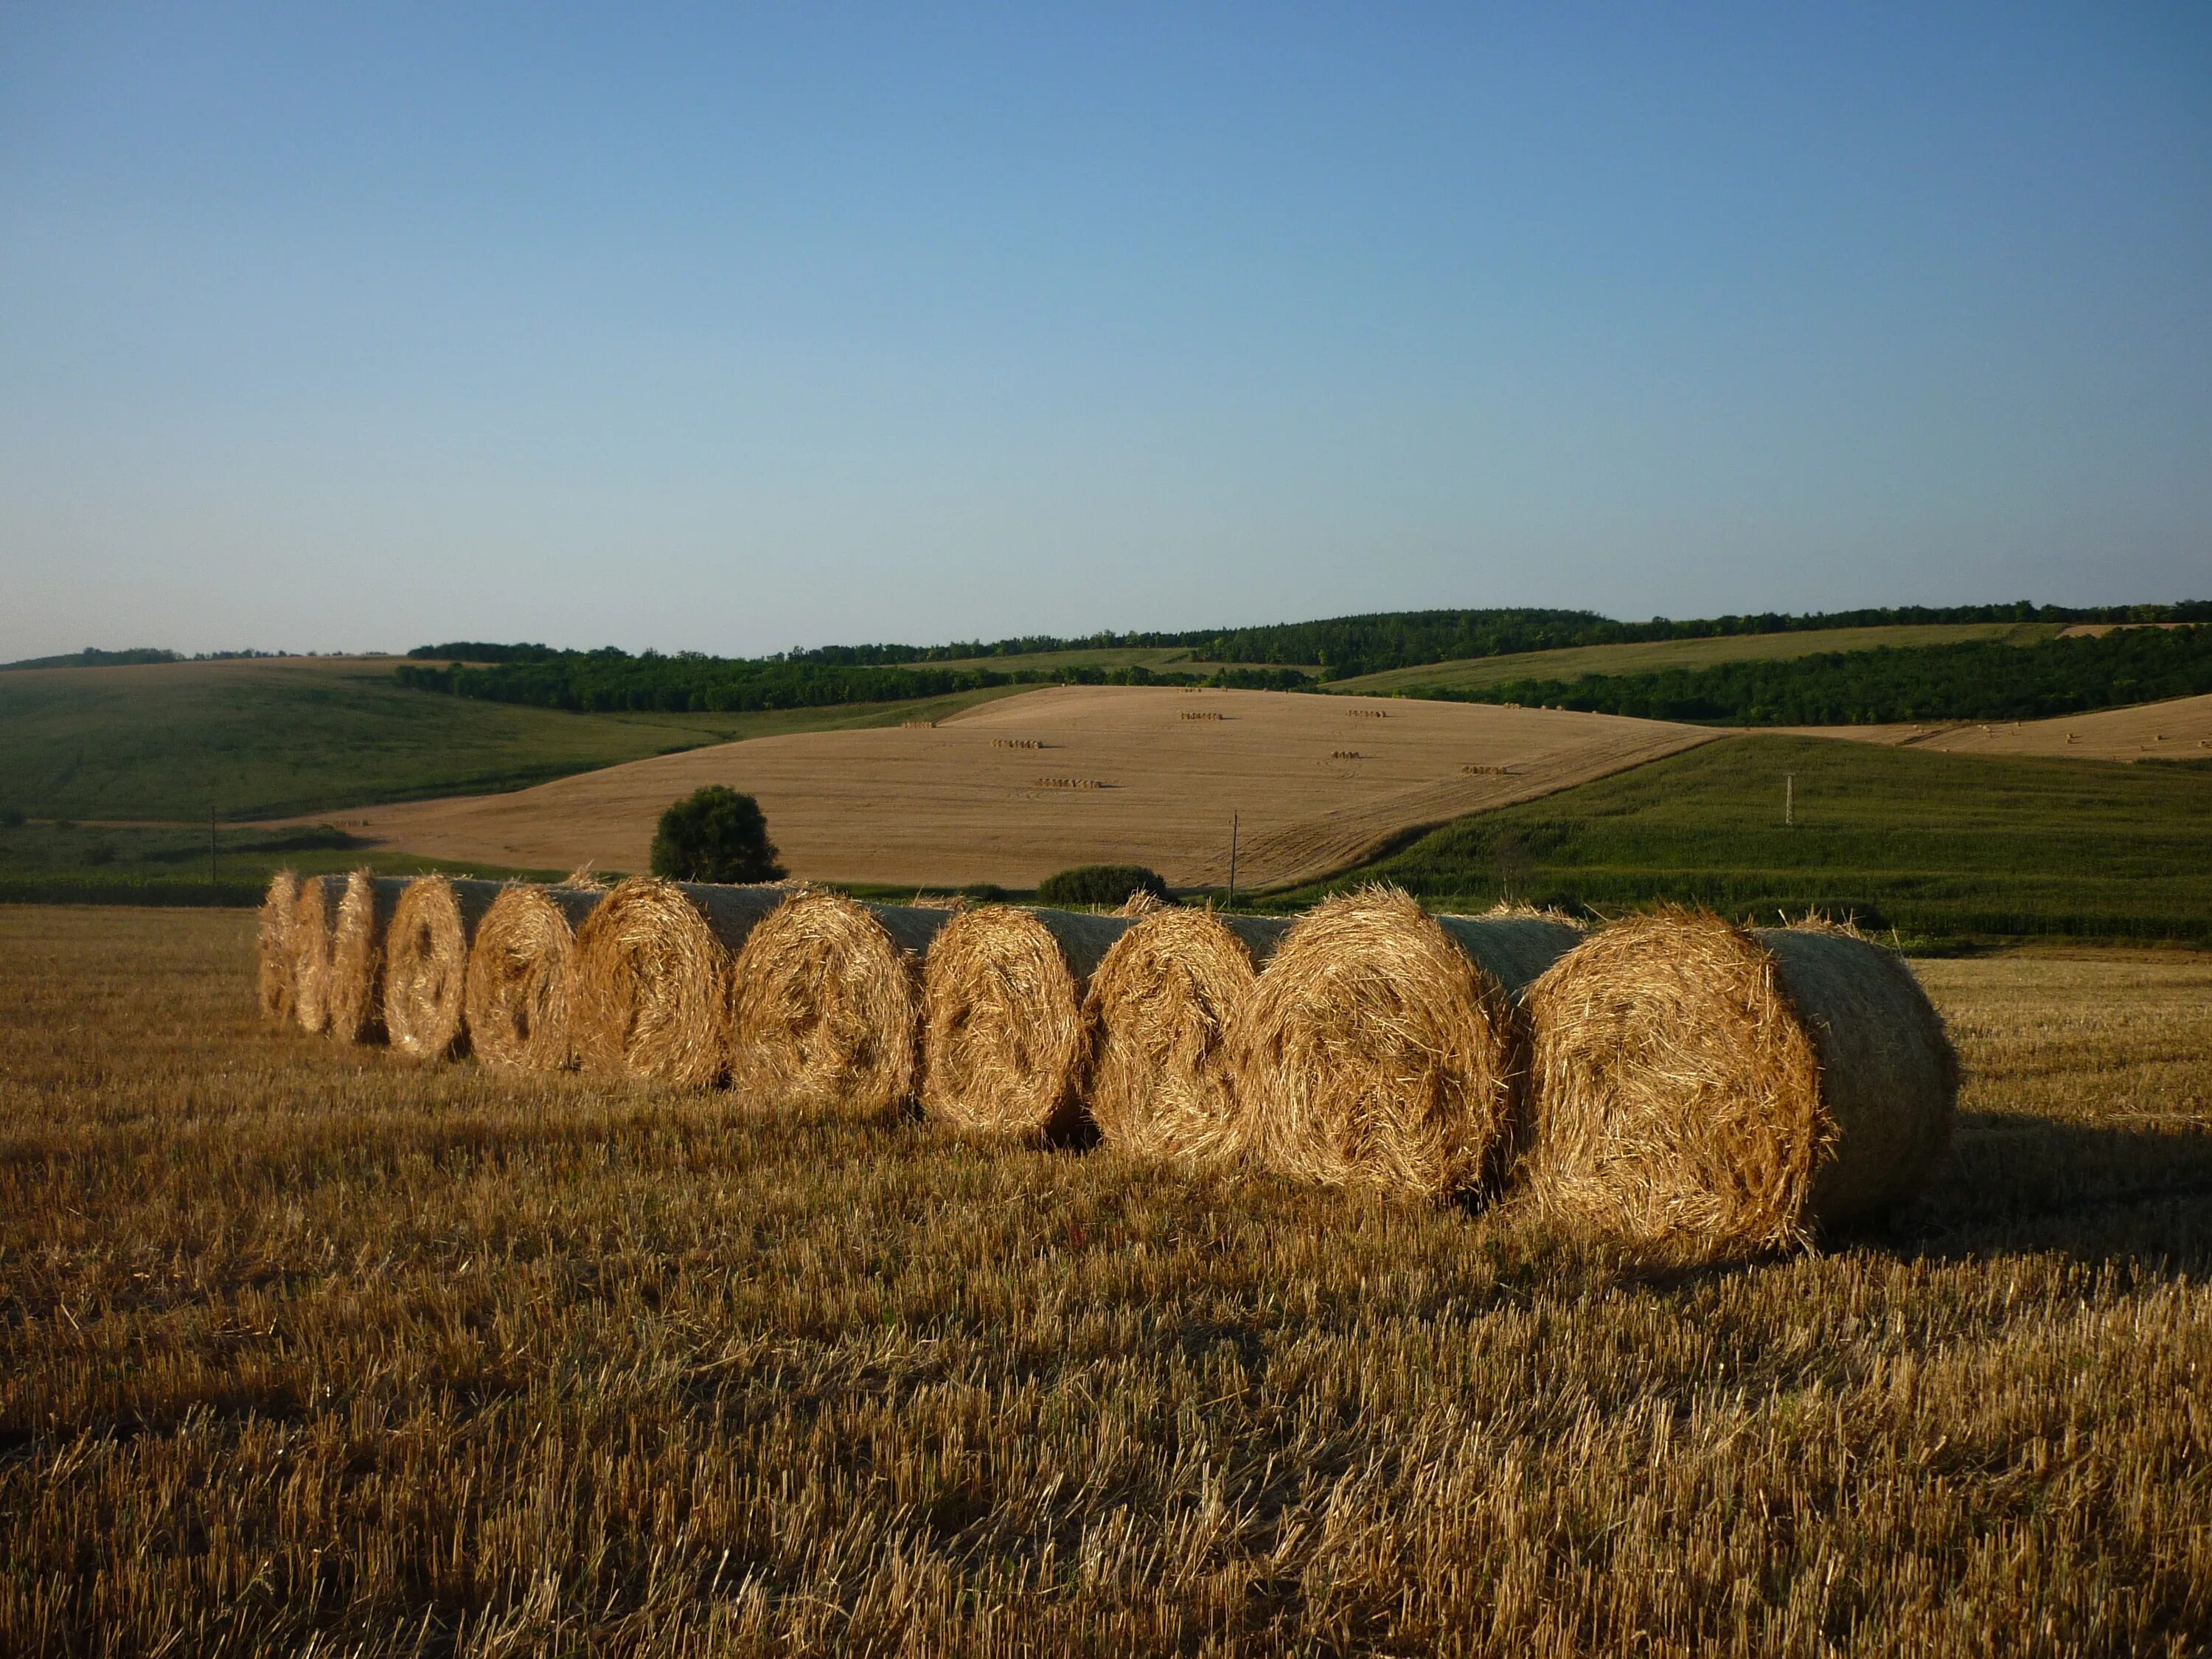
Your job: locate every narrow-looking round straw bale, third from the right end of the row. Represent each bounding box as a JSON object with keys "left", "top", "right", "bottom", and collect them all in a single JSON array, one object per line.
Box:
[{"left": 1086, "top": 902, "right": 1290, "bottom": 1168}]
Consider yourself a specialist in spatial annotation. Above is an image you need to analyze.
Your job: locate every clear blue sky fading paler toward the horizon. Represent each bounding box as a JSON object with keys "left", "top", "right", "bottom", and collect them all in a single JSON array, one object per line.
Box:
[{"left": 0, "top": 0, "right": 2212, "bottom": 659}]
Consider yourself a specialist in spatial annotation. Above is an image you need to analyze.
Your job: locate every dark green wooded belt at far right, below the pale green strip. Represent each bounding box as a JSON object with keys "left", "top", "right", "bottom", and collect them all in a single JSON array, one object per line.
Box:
[{"left": 1411, "top": 626, "right": 2212, "bottom": 726}]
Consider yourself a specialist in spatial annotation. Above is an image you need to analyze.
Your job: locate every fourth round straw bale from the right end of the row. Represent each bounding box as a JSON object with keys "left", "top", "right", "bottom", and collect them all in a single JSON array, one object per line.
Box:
[{"left": 922, "top": 905, "right": 1130, "bottom": 1141}]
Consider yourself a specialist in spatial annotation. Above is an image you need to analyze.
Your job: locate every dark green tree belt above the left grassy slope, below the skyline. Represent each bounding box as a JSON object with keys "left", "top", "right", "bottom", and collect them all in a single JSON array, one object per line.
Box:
[{"left": 394, "top": 650, "right": 1310, "bottom": 714}]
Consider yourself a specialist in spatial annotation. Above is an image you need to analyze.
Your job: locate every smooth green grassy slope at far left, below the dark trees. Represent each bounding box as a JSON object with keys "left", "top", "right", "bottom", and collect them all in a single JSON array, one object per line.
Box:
[{"left": 0, "top": 659, "right": 1018, "bottom": 821}]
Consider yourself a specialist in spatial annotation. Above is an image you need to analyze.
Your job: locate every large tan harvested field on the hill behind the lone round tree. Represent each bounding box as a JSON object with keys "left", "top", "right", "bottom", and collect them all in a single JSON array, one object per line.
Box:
[{"left": 316, "top": 686, "right": 1714, "bottom": 887}]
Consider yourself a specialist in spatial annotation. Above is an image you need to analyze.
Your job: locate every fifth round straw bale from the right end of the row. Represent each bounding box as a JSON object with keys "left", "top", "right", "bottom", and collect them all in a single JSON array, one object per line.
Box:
[{"left": 730, "top": 887, "right": 951, "bottom": 1117}]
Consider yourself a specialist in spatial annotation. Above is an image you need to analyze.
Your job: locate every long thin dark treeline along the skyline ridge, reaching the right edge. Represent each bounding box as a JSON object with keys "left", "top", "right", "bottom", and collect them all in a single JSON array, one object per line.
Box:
[{"left": 407, "top": 599, "right": 2212, "bottom": 679}]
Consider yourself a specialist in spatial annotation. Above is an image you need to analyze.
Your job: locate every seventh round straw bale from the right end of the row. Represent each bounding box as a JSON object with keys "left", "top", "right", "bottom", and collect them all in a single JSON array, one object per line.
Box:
[{"left": 462, "top": 883, "right": 606, "bottom": 1071}]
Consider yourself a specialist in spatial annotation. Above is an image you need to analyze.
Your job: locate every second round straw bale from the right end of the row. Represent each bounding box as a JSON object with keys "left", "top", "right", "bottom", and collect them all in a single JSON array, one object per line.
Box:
[{"left": 1230, "top": 887, "right": 1579, "bottom": 1199}]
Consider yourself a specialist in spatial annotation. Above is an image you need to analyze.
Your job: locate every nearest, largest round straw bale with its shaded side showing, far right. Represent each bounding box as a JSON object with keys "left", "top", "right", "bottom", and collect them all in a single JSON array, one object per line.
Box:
[{"left": 1528, "top": 911, "right": 1958, "bottom": 1259}]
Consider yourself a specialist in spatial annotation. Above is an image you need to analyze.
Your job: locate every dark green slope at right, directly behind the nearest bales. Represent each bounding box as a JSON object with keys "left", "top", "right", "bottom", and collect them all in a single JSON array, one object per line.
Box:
[{"left": 1283, "top": 737, "right": 2212, "bottom": 942}]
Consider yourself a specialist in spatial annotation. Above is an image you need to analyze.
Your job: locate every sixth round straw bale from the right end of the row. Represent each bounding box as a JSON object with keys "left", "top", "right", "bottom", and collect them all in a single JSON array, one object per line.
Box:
[{"left": 571, "top": 876, "right": 792, "bottom": 1088}]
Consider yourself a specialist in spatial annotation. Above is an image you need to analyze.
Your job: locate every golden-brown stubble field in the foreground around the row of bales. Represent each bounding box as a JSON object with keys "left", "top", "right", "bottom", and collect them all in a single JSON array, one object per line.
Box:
[{"left": 0, "top": 907, "right": 2212, "bottom": 1659}]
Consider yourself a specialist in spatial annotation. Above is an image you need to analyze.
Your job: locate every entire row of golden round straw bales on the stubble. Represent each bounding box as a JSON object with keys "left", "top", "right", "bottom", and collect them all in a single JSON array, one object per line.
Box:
[{"left": 261, "top": 872, "right": 1958, "bottom": 1256}]
